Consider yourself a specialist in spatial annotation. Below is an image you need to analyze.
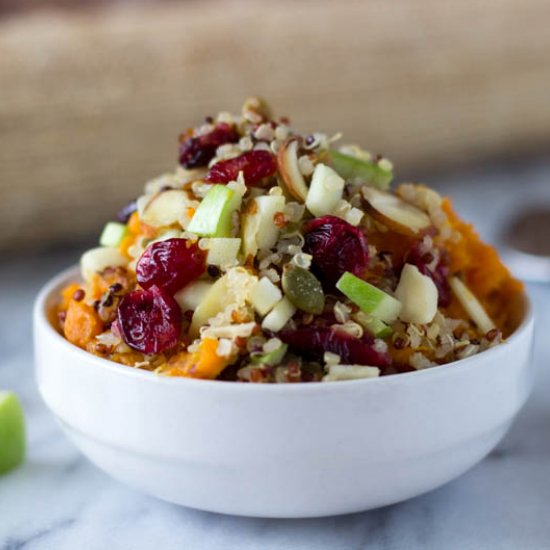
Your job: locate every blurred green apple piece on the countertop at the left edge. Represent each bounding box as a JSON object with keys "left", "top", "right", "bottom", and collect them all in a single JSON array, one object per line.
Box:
[{"left": 0, "top": 391, "right": 25, "bottom": 474}]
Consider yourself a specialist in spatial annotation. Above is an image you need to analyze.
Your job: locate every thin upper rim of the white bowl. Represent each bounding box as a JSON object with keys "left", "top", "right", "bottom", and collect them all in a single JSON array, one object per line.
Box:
[{"left": 33, "top": 265, "right": 535, "bottom": 393}]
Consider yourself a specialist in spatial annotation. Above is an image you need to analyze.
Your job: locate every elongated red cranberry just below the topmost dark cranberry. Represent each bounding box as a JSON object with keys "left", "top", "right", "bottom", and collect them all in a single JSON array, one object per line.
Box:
[{"left": 205, "top": 151, "right": 277, "bottom": 185}]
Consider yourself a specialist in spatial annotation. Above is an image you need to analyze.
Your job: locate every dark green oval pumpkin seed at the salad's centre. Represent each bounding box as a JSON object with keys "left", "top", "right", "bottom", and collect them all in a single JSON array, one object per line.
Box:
[{"left": 282, "top": 264, "right": 325, "bottom": 315}]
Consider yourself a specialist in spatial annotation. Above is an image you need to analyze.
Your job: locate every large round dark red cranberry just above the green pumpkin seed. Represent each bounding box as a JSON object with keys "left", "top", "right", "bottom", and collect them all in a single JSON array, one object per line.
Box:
[{"left": 304, "top": 216, "right": 369, "bottom": 290}]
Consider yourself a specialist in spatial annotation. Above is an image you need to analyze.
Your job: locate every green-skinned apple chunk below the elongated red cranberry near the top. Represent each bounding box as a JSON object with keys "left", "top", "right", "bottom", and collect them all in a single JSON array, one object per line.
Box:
[{"left": 187, "top": 185, "right": 241, "bottom": 237}]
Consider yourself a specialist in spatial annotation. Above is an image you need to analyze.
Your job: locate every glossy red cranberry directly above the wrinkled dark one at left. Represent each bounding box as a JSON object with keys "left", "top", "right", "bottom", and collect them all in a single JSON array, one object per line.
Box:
[{"left": 136, "top": 239, "right": 206, "bottom": 294}]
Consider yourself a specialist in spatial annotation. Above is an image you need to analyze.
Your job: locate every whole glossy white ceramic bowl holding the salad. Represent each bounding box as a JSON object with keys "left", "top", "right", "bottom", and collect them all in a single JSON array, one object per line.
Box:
[{"left": 34, "top": 270, "right": 533, "bottom": 518}]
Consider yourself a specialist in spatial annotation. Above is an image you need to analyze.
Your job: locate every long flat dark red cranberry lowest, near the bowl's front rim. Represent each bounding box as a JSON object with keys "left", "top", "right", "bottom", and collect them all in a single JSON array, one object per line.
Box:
[{"left": 277, "top": 326, "right": 391, "bottom": 367}]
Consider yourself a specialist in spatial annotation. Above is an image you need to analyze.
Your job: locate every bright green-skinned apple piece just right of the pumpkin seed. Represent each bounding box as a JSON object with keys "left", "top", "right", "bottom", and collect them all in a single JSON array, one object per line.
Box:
[{"left": 336, "top": 271, "right": 401, "bottom": 323}]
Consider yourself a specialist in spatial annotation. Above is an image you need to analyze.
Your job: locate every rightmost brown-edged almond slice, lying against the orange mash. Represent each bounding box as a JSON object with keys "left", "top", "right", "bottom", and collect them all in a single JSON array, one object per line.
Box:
[{"left": 362, "top": 187, "right": 432, "bottom": 235}]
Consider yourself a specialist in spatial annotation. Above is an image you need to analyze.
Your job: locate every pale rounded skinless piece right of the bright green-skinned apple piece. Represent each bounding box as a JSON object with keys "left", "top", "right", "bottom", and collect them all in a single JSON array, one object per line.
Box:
[{"left": 395, "top": 264, "right": 439, "bottom": 325}]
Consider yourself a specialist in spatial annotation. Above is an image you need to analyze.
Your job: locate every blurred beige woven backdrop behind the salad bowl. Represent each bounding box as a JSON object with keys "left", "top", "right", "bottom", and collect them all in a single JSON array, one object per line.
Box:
[{"left": 0, "top": 0, "right": 550, "bottom": 251}]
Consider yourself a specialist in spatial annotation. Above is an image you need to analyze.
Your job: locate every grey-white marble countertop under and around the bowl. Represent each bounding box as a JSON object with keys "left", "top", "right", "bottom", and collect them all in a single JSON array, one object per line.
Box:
[{"left": 0, "top": 162, "right": 550, "bottom": 550}]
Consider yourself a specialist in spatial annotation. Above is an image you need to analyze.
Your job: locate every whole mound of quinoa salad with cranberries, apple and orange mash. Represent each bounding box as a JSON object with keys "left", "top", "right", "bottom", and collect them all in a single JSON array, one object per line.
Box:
[{"left": 54, "top": 98, "right": 523, "bottom": 383}]
